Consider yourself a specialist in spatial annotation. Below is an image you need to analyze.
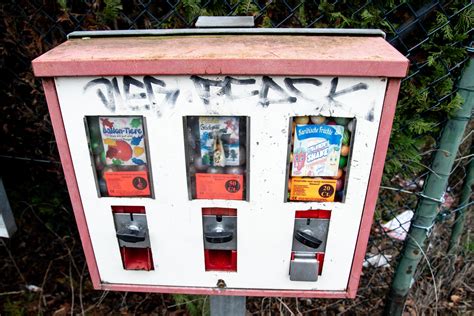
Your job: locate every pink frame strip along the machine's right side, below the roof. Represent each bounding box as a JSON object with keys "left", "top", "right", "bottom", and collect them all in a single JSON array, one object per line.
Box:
[{"left": 347, "top": 79, "right": 400, "bottom": 298}]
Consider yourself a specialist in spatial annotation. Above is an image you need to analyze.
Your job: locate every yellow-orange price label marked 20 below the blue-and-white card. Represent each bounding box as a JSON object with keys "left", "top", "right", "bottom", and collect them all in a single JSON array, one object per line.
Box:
[{"left": 290, "top": 178, "right": 337, "bottom": 202}]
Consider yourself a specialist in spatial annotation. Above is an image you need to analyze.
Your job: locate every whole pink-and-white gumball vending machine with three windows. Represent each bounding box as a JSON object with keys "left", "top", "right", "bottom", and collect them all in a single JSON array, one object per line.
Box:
[{"left": 33, "top": 28, "right": 408, "bottom": 298}]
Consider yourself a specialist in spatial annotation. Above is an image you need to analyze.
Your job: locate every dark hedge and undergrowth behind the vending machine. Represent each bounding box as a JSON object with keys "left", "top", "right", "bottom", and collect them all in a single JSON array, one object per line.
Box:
[{"left": 0, "top": 0, "right": 474, "bottom": 315}]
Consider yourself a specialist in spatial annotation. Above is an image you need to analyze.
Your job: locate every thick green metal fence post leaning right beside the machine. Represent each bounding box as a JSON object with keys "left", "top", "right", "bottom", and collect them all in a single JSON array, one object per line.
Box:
[{"left": 385, "top": 58, "right": 474, "bottom": 315}]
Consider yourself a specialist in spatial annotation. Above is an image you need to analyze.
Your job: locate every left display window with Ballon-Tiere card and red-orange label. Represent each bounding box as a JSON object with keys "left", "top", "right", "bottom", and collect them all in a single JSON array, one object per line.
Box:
[{"left": 85, "top": 116, "right": 153, "bottom": 197}]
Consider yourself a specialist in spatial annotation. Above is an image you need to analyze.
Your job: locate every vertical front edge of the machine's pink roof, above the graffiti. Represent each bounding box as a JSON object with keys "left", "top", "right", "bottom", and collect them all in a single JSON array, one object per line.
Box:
[{"left": 33, "top": 59, "right": 408, "bottom": 77}]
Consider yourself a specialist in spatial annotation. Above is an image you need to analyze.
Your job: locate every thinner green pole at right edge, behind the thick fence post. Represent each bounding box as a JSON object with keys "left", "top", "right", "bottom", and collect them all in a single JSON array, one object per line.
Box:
[{"left": 448, "top": 144, "right": 474, "bottom": 254}]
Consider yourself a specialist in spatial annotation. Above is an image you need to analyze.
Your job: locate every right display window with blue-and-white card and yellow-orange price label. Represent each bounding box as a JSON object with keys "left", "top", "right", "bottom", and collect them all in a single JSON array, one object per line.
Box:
[{"left": 286, "top": 116, "right": 356, "bottom": 202}]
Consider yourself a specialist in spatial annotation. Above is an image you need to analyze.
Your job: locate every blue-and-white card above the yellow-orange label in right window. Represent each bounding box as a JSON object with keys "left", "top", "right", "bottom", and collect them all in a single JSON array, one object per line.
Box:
[{"left": 291, "top": 125, "right": 344, "bottom": 177}]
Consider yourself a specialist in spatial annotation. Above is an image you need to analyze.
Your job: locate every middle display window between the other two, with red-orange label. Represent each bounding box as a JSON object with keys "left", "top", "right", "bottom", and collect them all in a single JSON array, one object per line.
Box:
[{"left": 184, "top": 116, "right": 249, "bottom": 200}]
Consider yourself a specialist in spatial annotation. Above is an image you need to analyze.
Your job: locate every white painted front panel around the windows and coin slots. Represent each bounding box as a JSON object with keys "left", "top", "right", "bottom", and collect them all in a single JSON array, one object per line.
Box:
[{"left": 56, "top": 76, "right": 387, "bottom": 291}]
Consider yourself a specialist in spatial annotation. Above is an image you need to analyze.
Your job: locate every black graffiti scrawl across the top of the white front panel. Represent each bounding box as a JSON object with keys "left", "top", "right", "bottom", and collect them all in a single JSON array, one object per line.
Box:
[{"left": 83, "top": 75, "right": 373, "bottom": 120}]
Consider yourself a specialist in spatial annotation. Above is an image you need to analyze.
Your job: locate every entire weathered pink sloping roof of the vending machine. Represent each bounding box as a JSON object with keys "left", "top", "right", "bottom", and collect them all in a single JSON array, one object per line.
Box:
[{"left": 32, "top": 35, "right": 408, "bottom": 77}]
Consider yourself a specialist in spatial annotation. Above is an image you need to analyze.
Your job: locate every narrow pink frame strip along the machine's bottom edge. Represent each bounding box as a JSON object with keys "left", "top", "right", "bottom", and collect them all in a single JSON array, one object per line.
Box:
[{"left": 100, "top": 283, "right": 349, "bottom": 298}]
